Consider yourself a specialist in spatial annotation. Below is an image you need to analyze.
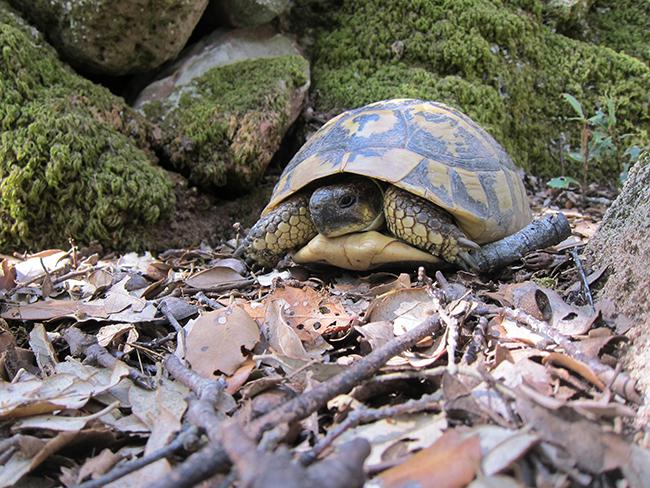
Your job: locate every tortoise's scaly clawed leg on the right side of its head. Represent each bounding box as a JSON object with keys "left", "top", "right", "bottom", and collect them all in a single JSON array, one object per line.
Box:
[{"left": 384, "top": 186, "right": 480, "bottom": 268}]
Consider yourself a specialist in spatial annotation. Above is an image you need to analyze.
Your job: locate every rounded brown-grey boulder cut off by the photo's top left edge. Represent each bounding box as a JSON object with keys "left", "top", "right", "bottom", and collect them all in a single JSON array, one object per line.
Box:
[{"left": 11, "top": 0, "right": 208, "bottom": 75}]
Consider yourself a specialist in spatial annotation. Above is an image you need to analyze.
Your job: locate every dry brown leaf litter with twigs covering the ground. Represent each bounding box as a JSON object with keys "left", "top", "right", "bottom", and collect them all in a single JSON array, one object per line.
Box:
[{"left": 0, "top": 190, "right": 650, "bottom": 488}]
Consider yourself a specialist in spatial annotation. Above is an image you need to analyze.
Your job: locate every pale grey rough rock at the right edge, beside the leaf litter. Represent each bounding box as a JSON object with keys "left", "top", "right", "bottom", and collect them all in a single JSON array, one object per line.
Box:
[{"left": 586, "top": 152, "right": 650, "bottom": 427}]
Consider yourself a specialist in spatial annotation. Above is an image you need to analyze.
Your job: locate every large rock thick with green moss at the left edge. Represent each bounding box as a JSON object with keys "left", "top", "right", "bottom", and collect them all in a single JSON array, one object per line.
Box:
[{"left": 0, "top": 2, "right": 174, "bottom": 252}]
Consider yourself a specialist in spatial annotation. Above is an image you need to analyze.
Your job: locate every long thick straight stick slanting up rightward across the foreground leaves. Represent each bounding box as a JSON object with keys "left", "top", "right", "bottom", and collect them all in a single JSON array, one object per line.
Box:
[{"left": 157, "top": 315, "right": 440, "bottom": 488}]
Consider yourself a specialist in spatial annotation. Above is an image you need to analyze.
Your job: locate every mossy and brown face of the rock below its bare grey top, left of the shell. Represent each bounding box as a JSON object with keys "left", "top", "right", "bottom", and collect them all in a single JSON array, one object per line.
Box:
[{"left": 144, "top": 55, "right": 309, "bottom": 191}]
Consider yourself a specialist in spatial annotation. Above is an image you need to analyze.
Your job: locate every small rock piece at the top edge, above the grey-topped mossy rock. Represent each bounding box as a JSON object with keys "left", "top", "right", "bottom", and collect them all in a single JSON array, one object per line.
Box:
[{"left": 208, "top": 0, "right": 291, "bottom": 27}]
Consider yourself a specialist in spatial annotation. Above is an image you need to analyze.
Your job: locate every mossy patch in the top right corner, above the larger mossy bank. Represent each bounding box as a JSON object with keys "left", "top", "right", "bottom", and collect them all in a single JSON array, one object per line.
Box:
[{"left": 589, "top": 0, "right": 650, "bottom": 64}]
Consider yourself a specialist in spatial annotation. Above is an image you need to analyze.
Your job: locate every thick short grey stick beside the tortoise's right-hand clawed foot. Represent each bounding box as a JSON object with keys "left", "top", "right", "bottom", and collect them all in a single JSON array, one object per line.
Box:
[{"left": 469, "top": 212, "right": 571, "bottom": 273}]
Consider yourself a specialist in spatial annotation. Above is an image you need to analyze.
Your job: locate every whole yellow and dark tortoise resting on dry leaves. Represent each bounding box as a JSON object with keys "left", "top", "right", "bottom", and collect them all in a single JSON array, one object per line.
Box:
[{"left": 236, "top": 99, "right": 531, "bottom": 269}]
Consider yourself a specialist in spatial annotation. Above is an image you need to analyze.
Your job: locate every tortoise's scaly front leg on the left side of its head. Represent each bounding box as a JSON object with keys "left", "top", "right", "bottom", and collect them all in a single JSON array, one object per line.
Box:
[{"left": 235, "top": 194, "right": 317, "bottom": 268}]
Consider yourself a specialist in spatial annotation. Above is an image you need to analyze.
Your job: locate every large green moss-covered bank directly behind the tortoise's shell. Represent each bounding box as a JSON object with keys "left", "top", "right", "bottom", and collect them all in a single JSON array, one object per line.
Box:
[{"left": 304, "top": 0, "right": 650, "bottom": 179}]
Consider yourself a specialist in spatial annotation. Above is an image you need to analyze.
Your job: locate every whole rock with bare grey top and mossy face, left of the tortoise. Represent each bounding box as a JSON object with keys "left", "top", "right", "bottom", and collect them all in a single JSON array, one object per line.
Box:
[{"left": 135, "top": 29, "right": 309, "bottom": 193}]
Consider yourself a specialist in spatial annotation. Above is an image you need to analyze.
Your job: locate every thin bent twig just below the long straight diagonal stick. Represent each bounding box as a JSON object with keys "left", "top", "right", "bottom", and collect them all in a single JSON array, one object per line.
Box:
[{"left": 300, "top": 390, "right": 442, "bottom": 465}]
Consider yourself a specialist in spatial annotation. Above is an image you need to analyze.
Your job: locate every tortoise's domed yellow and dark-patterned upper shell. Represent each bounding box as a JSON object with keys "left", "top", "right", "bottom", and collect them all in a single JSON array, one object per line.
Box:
[{"left": 262, "top": 99, "right": 531, "bottom": 244}]
